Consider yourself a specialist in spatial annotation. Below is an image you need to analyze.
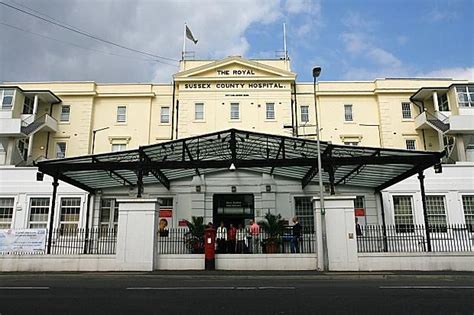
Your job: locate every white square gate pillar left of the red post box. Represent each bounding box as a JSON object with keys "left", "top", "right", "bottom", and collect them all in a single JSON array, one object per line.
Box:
[{"left": 116, "top": 199, "right": 160, "bottom": 271}]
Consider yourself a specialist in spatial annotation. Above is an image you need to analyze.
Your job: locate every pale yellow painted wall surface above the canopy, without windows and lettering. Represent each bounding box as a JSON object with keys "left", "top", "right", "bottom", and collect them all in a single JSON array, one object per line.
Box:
[{"left": 4, "top": 57, "right": 470, "bottom": 159}]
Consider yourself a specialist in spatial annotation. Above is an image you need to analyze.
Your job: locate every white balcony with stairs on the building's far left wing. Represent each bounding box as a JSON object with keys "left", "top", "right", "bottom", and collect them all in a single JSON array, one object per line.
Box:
[{"left": 0, "top": 114, "right": 58, "bottom": 137}]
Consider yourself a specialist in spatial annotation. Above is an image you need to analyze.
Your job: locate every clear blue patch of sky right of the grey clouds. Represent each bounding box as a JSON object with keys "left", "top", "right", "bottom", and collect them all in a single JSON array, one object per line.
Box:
[{"left": 246, "top": 0, "right": 474, "bottom": 81}]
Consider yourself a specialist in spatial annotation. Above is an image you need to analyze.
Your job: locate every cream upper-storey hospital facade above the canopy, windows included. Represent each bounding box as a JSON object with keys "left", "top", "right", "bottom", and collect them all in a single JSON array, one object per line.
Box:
[{"left": 0, "top": 57, "right": 474, "bottom": 164}]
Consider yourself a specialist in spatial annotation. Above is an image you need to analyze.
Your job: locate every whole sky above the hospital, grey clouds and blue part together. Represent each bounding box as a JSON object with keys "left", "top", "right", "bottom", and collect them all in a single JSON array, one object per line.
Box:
[{"left": 0, "top": 0, "right": 474, "bottom": 83}]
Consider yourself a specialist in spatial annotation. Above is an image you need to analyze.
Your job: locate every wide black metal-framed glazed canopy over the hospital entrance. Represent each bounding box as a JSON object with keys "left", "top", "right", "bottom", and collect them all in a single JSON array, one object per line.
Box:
[{"left": 37, "top": 129, "right": 444, "bottom": 196}]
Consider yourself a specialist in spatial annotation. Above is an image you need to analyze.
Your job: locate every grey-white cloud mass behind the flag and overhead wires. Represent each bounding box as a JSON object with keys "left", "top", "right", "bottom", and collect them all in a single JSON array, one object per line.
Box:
[{"left": 0, "top": 0, "right": 286, "bottom": 82}]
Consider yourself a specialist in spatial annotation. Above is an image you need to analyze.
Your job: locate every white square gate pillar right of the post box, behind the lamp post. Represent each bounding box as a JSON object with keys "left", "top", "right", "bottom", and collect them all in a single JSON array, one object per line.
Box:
[{"left": 313, "top": 196, "right": 359, "bottom": 271}]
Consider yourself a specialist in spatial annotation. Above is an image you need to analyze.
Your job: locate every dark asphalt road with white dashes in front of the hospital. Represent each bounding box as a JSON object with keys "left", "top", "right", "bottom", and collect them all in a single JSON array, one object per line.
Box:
[{"left": 0, "top": 272, "right": 474, "bottom": 315}]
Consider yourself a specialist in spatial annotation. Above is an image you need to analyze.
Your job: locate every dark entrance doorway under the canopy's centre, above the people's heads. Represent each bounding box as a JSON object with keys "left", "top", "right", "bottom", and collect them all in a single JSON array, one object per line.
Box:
[{"left": 213, "top": 194, "right": 255, "bottom": 227}]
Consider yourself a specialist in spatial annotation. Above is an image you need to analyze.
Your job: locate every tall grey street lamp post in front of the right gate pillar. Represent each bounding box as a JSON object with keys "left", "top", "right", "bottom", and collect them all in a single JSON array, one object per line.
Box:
[{"left": 313, "top": 67, "right": 329, "bottom": 271}]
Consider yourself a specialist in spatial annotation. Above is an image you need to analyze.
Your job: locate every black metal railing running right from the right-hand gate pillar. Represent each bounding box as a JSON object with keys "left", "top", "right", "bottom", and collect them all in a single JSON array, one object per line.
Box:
[{"left": 357, "top": 224, "right": 474, "bottom": 253}]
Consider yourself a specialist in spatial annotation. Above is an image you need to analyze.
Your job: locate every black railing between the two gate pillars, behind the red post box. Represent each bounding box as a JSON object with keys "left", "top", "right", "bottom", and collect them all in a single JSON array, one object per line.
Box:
[{"left": 158, "top": 228, "right": 316, "bottom": 254}]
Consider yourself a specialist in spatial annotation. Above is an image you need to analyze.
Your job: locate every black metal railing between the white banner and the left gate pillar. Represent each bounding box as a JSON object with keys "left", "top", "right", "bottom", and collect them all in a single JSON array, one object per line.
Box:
[{"left": 1, "top": 228, "right": 117, "bottom": 255}]
